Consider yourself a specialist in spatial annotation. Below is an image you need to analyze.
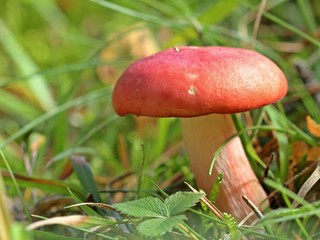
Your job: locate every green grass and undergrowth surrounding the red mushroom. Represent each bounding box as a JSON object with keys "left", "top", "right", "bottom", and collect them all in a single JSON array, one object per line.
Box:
[{"left": 0, "top": 0, "right": 320, "bottom": 240}]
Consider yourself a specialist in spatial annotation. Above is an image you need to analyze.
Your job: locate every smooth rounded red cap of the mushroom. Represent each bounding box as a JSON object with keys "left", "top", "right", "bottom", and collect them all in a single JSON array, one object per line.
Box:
[{"left": 113, "top": 47, "right": 288, "bottom": 117}]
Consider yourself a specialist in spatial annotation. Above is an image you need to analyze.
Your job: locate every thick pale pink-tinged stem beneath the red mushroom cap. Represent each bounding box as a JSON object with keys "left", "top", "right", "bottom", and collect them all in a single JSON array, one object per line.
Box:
[{"left": 181, "top": 114, "right": 267, "bottom": 220}]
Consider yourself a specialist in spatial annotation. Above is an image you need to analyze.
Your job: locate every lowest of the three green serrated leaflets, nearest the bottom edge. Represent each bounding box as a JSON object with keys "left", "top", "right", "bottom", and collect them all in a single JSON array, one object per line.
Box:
[{"left": 138, "top": 215, "right": 186, "bottom": 237}]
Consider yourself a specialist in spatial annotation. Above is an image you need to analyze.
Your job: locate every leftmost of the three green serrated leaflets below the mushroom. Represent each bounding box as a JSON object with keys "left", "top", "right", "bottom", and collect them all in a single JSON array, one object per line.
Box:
[{"left": 113, "top": 197, "right": 169, "bottom": 218}]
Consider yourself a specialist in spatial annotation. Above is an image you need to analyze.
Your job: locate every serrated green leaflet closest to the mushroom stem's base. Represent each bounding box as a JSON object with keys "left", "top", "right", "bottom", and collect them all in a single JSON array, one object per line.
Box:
[{"left": 164, "top": 192, "right": 204, "bottom": 216}]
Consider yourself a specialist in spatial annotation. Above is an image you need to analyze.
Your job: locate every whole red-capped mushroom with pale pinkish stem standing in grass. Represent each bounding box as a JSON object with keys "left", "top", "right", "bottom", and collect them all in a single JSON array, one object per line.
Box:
[{"left": 113, "top": 46, "right": 288, "bottom": 220}]
